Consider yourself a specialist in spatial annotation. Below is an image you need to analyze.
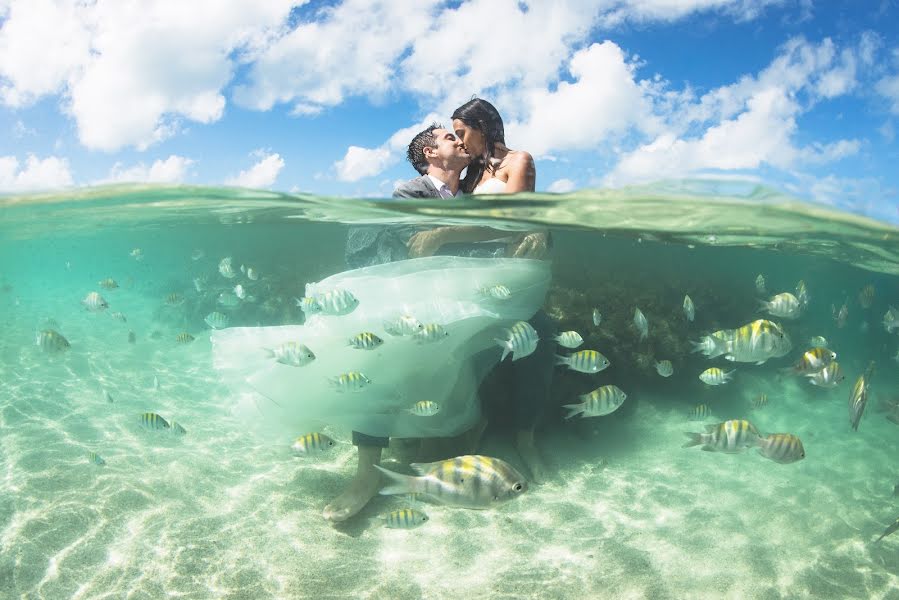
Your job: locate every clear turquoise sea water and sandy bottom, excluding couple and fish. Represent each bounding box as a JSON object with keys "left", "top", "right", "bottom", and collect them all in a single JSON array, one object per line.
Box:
[{"left": 0, "top": 182, "right": 899, "bottom": 598}]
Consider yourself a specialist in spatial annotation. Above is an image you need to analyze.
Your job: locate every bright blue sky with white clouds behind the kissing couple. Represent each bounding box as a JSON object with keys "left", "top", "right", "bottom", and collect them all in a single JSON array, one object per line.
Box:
[{"left": 0, "top": 0, "right": 899, "bottom": 222}]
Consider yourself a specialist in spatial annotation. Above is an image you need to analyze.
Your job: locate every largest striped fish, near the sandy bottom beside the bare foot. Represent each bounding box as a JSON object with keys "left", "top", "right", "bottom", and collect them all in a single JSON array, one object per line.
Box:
[{"left": 375, "top": 455, "right": 528, "bottom": 508}]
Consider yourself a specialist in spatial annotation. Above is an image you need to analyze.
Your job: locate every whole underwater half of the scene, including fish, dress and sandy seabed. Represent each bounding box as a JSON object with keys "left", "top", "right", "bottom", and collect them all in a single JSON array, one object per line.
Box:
[{"left": 0, "top": 181, "right": 899, "bottom": 599}]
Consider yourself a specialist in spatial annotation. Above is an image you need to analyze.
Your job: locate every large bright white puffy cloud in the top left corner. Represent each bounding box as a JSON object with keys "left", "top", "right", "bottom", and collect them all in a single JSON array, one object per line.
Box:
[{"left": 0, "top": 0, "right": 294, "bottom": 150}]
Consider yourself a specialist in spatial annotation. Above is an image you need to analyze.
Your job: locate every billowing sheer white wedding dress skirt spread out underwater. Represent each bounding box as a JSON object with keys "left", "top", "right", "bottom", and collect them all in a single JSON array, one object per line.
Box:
[{"left": 211, "top": 255, "right": 551, "bottom": 437}]
